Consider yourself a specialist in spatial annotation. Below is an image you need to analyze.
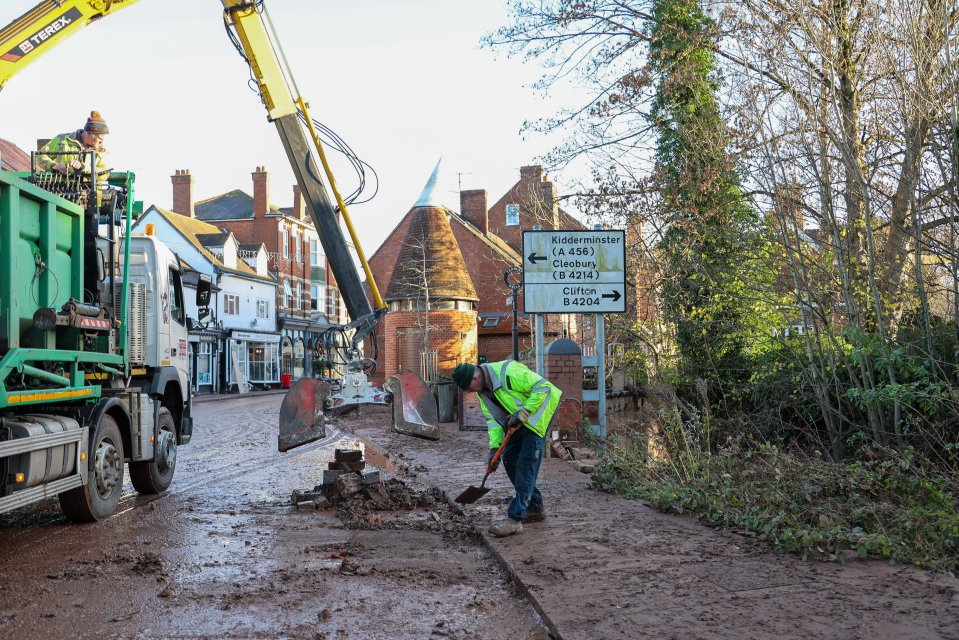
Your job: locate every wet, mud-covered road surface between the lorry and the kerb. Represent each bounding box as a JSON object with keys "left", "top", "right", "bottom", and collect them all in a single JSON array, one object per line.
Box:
[{"left": 0, "top": 395, "right": 547, "bottom": 639}]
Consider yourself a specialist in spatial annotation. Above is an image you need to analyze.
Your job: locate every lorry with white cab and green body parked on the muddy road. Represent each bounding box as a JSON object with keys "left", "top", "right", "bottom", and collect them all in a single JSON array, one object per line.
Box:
[{"left": 0, "top": 163, "right": 211, "bottom": 522}]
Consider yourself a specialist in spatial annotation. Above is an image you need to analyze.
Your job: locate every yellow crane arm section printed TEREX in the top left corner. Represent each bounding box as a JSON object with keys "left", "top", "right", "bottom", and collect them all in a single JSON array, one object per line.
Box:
[{"left": 0, "top": 0, "right": 139, "bottom": 88}]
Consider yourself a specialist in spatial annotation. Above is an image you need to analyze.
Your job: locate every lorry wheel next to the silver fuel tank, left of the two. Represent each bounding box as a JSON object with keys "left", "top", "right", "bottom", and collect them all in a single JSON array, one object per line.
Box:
[{"left": 58, "top": 414, "right": 123, "bottom": 522}]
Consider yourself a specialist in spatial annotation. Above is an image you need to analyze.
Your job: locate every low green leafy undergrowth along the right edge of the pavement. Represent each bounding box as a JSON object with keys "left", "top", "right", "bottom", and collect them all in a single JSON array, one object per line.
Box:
[{"left": 593, "top": 438, "right": 959, "bottom": 574}]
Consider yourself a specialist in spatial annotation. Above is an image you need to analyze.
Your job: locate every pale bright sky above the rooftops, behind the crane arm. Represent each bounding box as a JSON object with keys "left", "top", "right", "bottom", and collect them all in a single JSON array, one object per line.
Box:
[{"left": 0, "top": 0, "right": 575, "bottom": 255}]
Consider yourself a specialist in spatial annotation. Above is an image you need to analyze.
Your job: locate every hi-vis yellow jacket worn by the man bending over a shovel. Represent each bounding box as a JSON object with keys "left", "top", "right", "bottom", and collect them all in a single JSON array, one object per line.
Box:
[{"left": 477, "top": 360, "right": 563, "bottom": 449}]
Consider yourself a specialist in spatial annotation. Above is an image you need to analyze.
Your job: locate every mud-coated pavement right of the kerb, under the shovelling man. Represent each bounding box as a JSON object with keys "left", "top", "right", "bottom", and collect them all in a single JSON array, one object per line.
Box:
[{"left": 340, "top": 409, "right": 959, "bottom": 640}]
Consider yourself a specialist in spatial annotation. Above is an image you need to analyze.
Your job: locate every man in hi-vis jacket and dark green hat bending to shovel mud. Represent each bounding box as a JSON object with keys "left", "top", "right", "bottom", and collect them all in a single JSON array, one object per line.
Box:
[{"left": 453, "top": 360, "right": 562, "bottom": 537}]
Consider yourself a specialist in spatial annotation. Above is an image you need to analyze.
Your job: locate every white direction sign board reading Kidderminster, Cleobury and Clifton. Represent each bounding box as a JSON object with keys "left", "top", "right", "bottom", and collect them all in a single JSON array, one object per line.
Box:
[{"left": 523, "top": 230, "right": 626, "bottom": 313}]
